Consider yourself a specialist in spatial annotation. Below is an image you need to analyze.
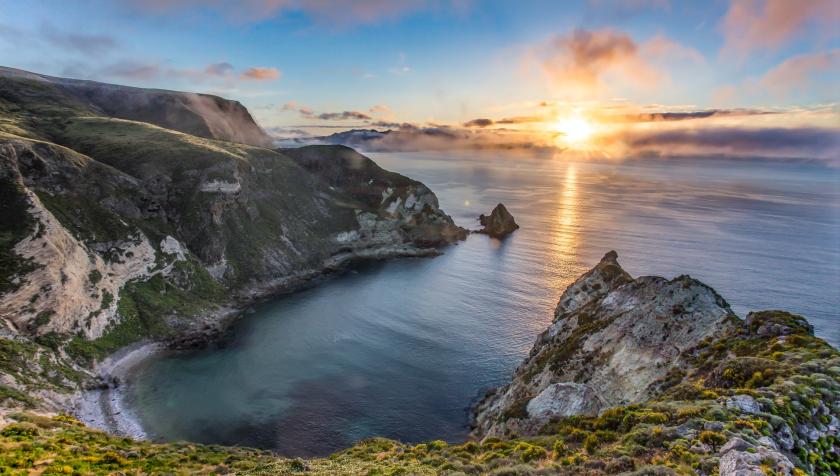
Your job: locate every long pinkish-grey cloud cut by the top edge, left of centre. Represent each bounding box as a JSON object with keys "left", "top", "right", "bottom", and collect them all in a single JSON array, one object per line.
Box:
[{"left": 122, "top": 0, "right": 470, "bottom": 27}]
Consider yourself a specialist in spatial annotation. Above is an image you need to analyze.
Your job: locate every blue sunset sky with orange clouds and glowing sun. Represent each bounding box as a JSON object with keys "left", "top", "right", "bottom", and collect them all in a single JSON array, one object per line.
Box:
[{"left": 0, "top": 0, "right": 840, "bottom": 158}]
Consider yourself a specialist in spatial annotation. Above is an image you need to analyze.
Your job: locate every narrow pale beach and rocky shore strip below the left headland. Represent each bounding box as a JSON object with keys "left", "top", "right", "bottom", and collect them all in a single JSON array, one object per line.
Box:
[{"left": 71, "top": 245, "right": 450, "bottom": 440}]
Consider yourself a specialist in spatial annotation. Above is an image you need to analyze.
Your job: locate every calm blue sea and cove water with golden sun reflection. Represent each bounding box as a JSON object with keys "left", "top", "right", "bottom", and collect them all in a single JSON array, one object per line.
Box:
[{"left": 127, "top": 153, "right": 840, "bottom": 455}]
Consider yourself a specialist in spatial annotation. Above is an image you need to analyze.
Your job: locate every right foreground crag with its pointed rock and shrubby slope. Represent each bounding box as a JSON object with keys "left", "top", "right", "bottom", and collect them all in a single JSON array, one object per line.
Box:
[{"left": 474, "top": 252, "right": 840, "bottom": 475}]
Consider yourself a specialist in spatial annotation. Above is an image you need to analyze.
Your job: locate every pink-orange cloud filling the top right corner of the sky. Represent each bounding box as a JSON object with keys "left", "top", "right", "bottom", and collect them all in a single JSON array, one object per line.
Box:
[{"left": 721, "top": 0, "right": 840, "bottom": 55}]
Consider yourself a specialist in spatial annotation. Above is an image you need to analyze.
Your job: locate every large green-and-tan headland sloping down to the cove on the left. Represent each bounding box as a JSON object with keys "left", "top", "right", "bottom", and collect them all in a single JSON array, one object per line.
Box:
[{"left": 0, "top": 69, "right": 466, "bottom": 412}]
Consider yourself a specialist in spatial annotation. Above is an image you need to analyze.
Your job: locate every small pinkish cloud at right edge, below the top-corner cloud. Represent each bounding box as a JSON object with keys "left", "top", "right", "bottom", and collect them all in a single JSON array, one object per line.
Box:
[{"left": 759, "top": 49, "right": 840, "bottom": 96}]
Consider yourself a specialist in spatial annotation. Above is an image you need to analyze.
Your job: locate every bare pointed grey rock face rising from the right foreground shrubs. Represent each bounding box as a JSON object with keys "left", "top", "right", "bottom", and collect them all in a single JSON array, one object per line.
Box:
[{"left": 474, "top": 251, "right": 734, "bottom": 437}]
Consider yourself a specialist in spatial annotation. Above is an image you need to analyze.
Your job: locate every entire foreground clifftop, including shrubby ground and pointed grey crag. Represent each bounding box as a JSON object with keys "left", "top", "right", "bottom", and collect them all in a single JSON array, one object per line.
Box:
[{"left": 0, "top": 252, "right": 840, "bottom": 475}]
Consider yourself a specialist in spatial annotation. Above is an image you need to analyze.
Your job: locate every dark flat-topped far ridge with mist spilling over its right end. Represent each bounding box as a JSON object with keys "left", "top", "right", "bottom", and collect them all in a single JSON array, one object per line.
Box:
[{"left": 0, "top": 66, "right": 272, "bottom": 147}]
